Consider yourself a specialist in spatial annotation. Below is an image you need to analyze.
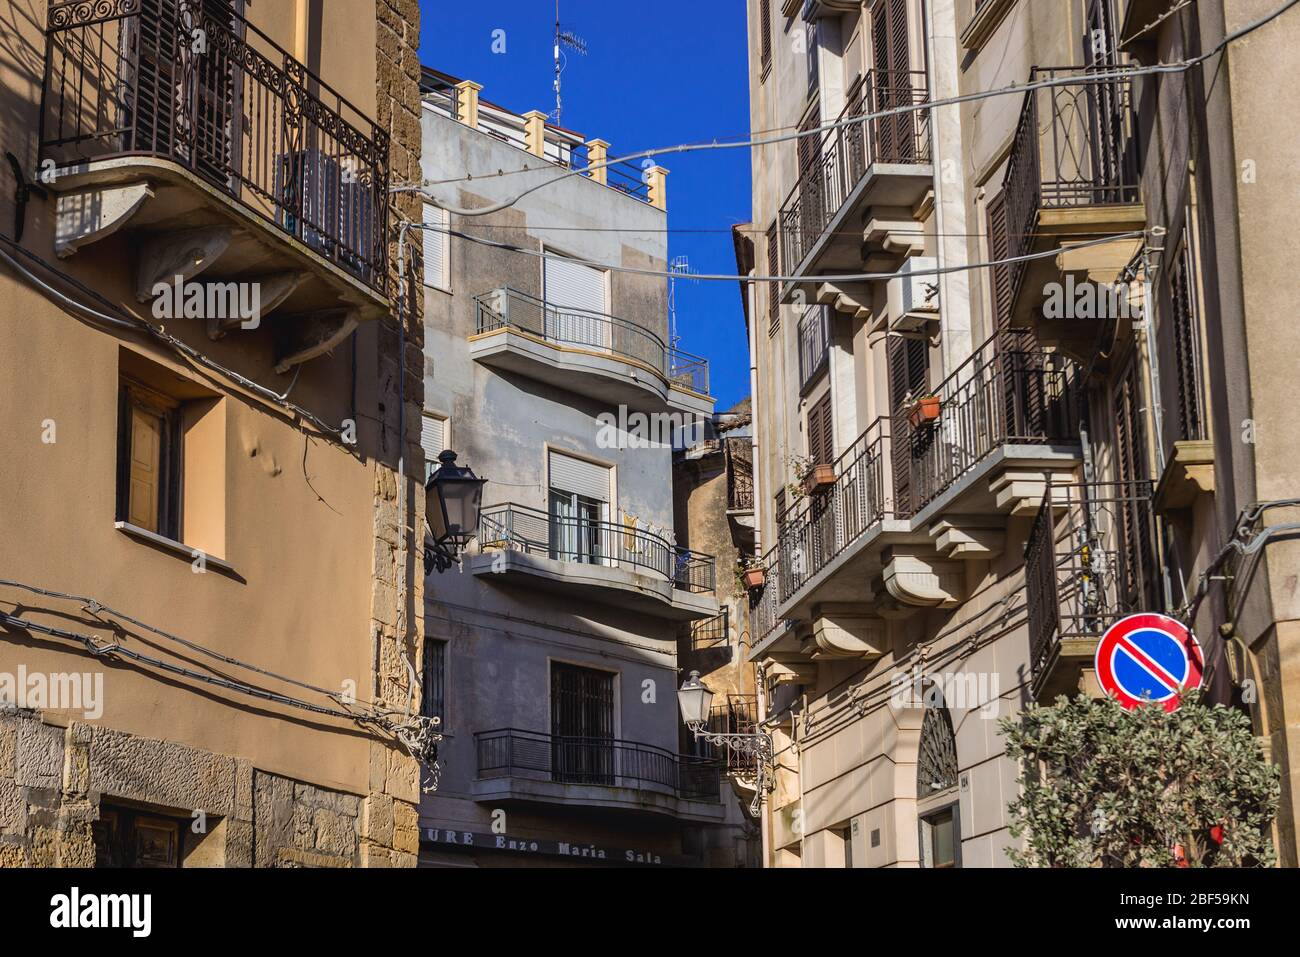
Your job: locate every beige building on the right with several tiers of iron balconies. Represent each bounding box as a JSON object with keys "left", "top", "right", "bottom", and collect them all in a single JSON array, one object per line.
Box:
[{"left": 737, "top": 0, "right": 1297, "bottom": 866}]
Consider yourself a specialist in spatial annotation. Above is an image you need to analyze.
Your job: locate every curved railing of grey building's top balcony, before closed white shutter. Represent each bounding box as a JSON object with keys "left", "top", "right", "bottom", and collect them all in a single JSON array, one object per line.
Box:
[{"left": 475, "top": 286, "right": 709, "bottom": 394}]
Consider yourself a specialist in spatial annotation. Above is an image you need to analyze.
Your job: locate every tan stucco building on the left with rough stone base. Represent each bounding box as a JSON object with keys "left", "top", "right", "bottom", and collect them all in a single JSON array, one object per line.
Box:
[{"left": 0, "top": 0, "right": 424, "bottom": 866}]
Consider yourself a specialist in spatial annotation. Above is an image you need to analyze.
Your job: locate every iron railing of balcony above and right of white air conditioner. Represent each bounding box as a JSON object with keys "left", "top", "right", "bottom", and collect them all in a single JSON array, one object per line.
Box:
[{"left": 1002, "top": 66, "right": 1141, "bottom": 306}]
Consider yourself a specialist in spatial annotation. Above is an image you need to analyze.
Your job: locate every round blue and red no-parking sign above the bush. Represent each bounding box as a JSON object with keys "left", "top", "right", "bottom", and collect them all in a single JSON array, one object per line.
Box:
[{"left": 1095, "top": 614, "right": 1204, "bottom": 711}]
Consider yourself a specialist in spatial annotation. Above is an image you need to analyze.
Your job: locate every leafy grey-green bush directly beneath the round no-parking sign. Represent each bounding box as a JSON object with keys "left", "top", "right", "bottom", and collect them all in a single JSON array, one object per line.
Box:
[{"left": 1000, "top": 692, "right": 1281, "bottom": 867}]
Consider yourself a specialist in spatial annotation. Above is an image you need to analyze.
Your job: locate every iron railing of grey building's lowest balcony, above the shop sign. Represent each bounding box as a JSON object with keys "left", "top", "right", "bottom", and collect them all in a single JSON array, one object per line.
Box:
[{"left": 475, "top": 728, "right": 722, "bottom": 802}]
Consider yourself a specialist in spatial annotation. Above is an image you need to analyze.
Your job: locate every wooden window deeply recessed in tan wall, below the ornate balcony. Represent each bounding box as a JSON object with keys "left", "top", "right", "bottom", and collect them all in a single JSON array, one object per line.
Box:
[{"left": 117, "top": 381, "right": 181, "bottom": 541}]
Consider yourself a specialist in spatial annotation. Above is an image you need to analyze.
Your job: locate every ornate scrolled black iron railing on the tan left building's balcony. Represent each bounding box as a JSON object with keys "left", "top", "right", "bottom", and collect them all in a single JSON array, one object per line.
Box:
[{"left": 38, "top": 0, "right": 389, "bottom": 294}]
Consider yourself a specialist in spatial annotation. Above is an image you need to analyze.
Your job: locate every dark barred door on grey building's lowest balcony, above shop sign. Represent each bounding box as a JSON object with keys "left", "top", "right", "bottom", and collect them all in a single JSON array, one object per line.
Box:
[{"left": 551, "top": 662, "right": 614, "bottom": 787}]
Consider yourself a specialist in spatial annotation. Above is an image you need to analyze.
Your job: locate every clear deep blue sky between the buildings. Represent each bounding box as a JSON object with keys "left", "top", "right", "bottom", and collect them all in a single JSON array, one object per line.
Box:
[{"left": 420, "top": 0, "right": 750, "bottom": 410}]
